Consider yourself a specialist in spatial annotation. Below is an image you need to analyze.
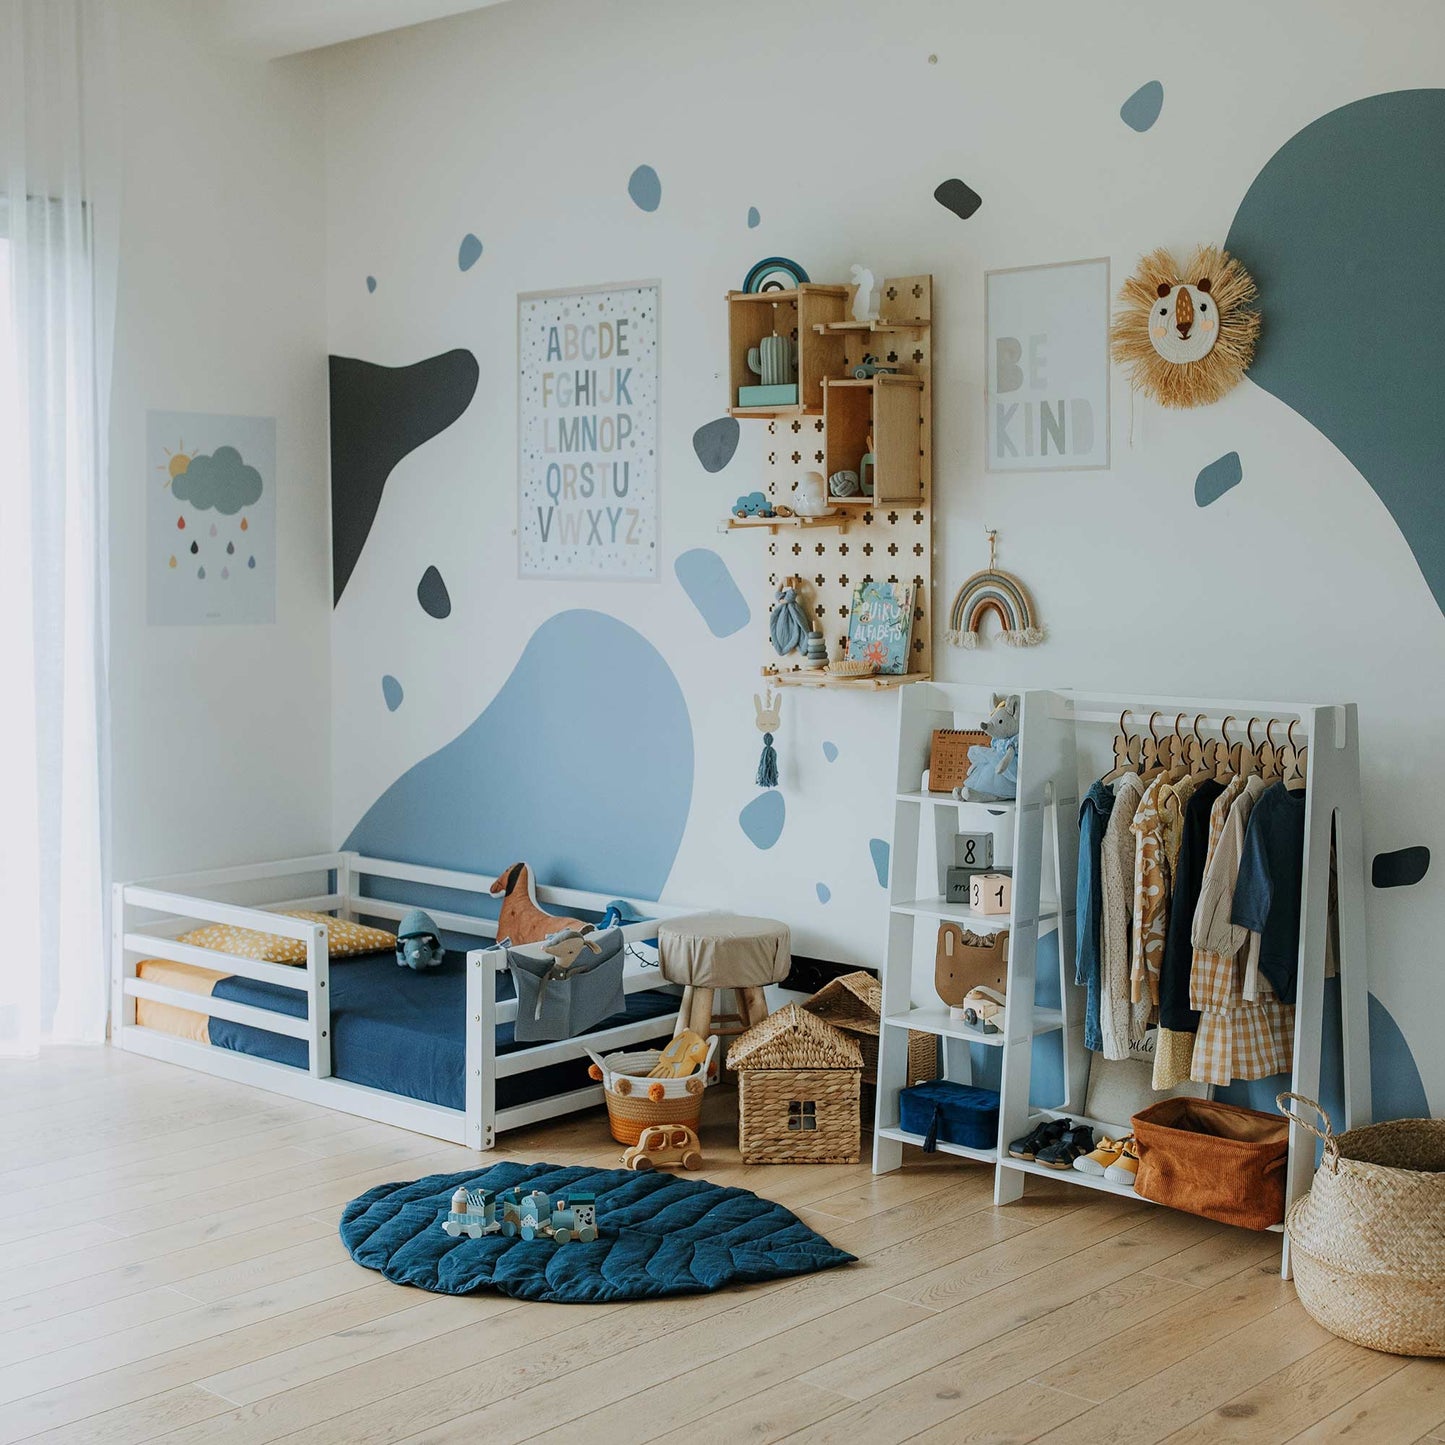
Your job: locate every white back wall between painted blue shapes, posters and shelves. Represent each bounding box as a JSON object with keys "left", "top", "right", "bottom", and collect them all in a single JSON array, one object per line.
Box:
[{"left": 325, "top": 0, "right": 1445, "bottom": 1108}]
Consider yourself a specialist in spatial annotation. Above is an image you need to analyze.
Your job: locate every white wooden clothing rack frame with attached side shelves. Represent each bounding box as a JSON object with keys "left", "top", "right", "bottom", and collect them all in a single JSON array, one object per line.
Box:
[{"left": 874, "top": 683, "right": 1371, "bottom": 1276}]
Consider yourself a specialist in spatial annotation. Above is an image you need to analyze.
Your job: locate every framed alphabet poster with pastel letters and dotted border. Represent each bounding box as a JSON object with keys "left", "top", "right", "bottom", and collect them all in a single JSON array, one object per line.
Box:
[{"left": 517, "top": 282, "right": 659, "bottom": 581}]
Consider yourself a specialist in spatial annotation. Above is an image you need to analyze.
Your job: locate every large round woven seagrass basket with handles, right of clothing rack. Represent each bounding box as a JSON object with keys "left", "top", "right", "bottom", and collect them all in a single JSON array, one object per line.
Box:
[{"left": 1274, "top": 1094, "right": 1445, "bottom": 1355}]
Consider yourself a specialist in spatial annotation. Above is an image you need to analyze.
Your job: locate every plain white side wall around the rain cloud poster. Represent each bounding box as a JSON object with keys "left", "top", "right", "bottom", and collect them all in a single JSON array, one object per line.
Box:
[{"left": 110, "top": 0, "right": 331, "bottom": 879}]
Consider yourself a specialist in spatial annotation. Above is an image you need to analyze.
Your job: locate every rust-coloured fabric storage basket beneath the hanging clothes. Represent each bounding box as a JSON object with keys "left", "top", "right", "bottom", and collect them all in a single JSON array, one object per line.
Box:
[{"left": 1134, "top": 1098, "right": 1289, "bottom": 1230}]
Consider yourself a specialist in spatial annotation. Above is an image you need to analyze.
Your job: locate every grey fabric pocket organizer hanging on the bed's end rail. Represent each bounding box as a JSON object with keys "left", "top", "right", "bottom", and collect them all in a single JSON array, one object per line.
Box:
[{"left": 507, "top": 928, "right": 627, "bottom": 1043}]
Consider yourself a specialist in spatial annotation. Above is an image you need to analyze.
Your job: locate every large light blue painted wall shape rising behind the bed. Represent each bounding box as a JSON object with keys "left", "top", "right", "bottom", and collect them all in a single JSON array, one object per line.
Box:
[{"left": 344, "top": 610, "right": 694, "bottom": 899}]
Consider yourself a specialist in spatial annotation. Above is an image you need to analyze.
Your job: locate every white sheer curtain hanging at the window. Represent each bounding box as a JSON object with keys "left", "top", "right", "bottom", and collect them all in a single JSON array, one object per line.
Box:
[{"left": 0, "top": 0, "right": 118, "bottom": 1053}]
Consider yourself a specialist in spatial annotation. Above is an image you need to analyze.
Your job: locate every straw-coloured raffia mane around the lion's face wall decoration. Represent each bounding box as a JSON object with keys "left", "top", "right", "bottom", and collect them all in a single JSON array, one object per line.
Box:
[{"left": 1108, "top": 246, "right": 1260, "bottom": 407}]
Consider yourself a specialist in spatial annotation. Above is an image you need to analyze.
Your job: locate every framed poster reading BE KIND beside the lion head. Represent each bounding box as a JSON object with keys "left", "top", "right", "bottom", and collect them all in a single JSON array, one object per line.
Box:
[{"left": 984, "top": 257, "right": 1108, "bottom": 471}]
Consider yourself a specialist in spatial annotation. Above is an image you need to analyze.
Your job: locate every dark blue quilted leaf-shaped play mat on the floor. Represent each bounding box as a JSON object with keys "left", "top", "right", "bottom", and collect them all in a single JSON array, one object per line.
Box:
[{"left": 341, "top": 1162, "right": 854, "bottom": 1305}]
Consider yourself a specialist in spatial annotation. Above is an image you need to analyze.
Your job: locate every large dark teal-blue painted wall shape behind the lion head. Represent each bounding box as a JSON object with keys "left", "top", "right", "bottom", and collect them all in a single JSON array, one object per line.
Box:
[{"left": 1225, "top": 90, "right": 1445, "bottom": 610}]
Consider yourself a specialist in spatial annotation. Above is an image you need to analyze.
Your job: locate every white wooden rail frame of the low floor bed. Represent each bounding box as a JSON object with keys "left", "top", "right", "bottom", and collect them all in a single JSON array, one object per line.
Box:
[{"left": 111, "top": 853, "right": 692, "bottom": 1149}]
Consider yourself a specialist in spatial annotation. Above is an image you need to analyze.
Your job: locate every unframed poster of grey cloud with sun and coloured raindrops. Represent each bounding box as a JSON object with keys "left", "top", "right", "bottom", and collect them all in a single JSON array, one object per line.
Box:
[{"left": 146, "top": 412, "right": 276, "bottom": 627}]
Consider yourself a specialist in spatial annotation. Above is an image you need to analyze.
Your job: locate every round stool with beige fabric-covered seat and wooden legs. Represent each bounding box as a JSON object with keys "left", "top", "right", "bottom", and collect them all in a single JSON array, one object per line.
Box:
[{"left": 657, "top": 913, "right": 793, "bottom": 1039}]
